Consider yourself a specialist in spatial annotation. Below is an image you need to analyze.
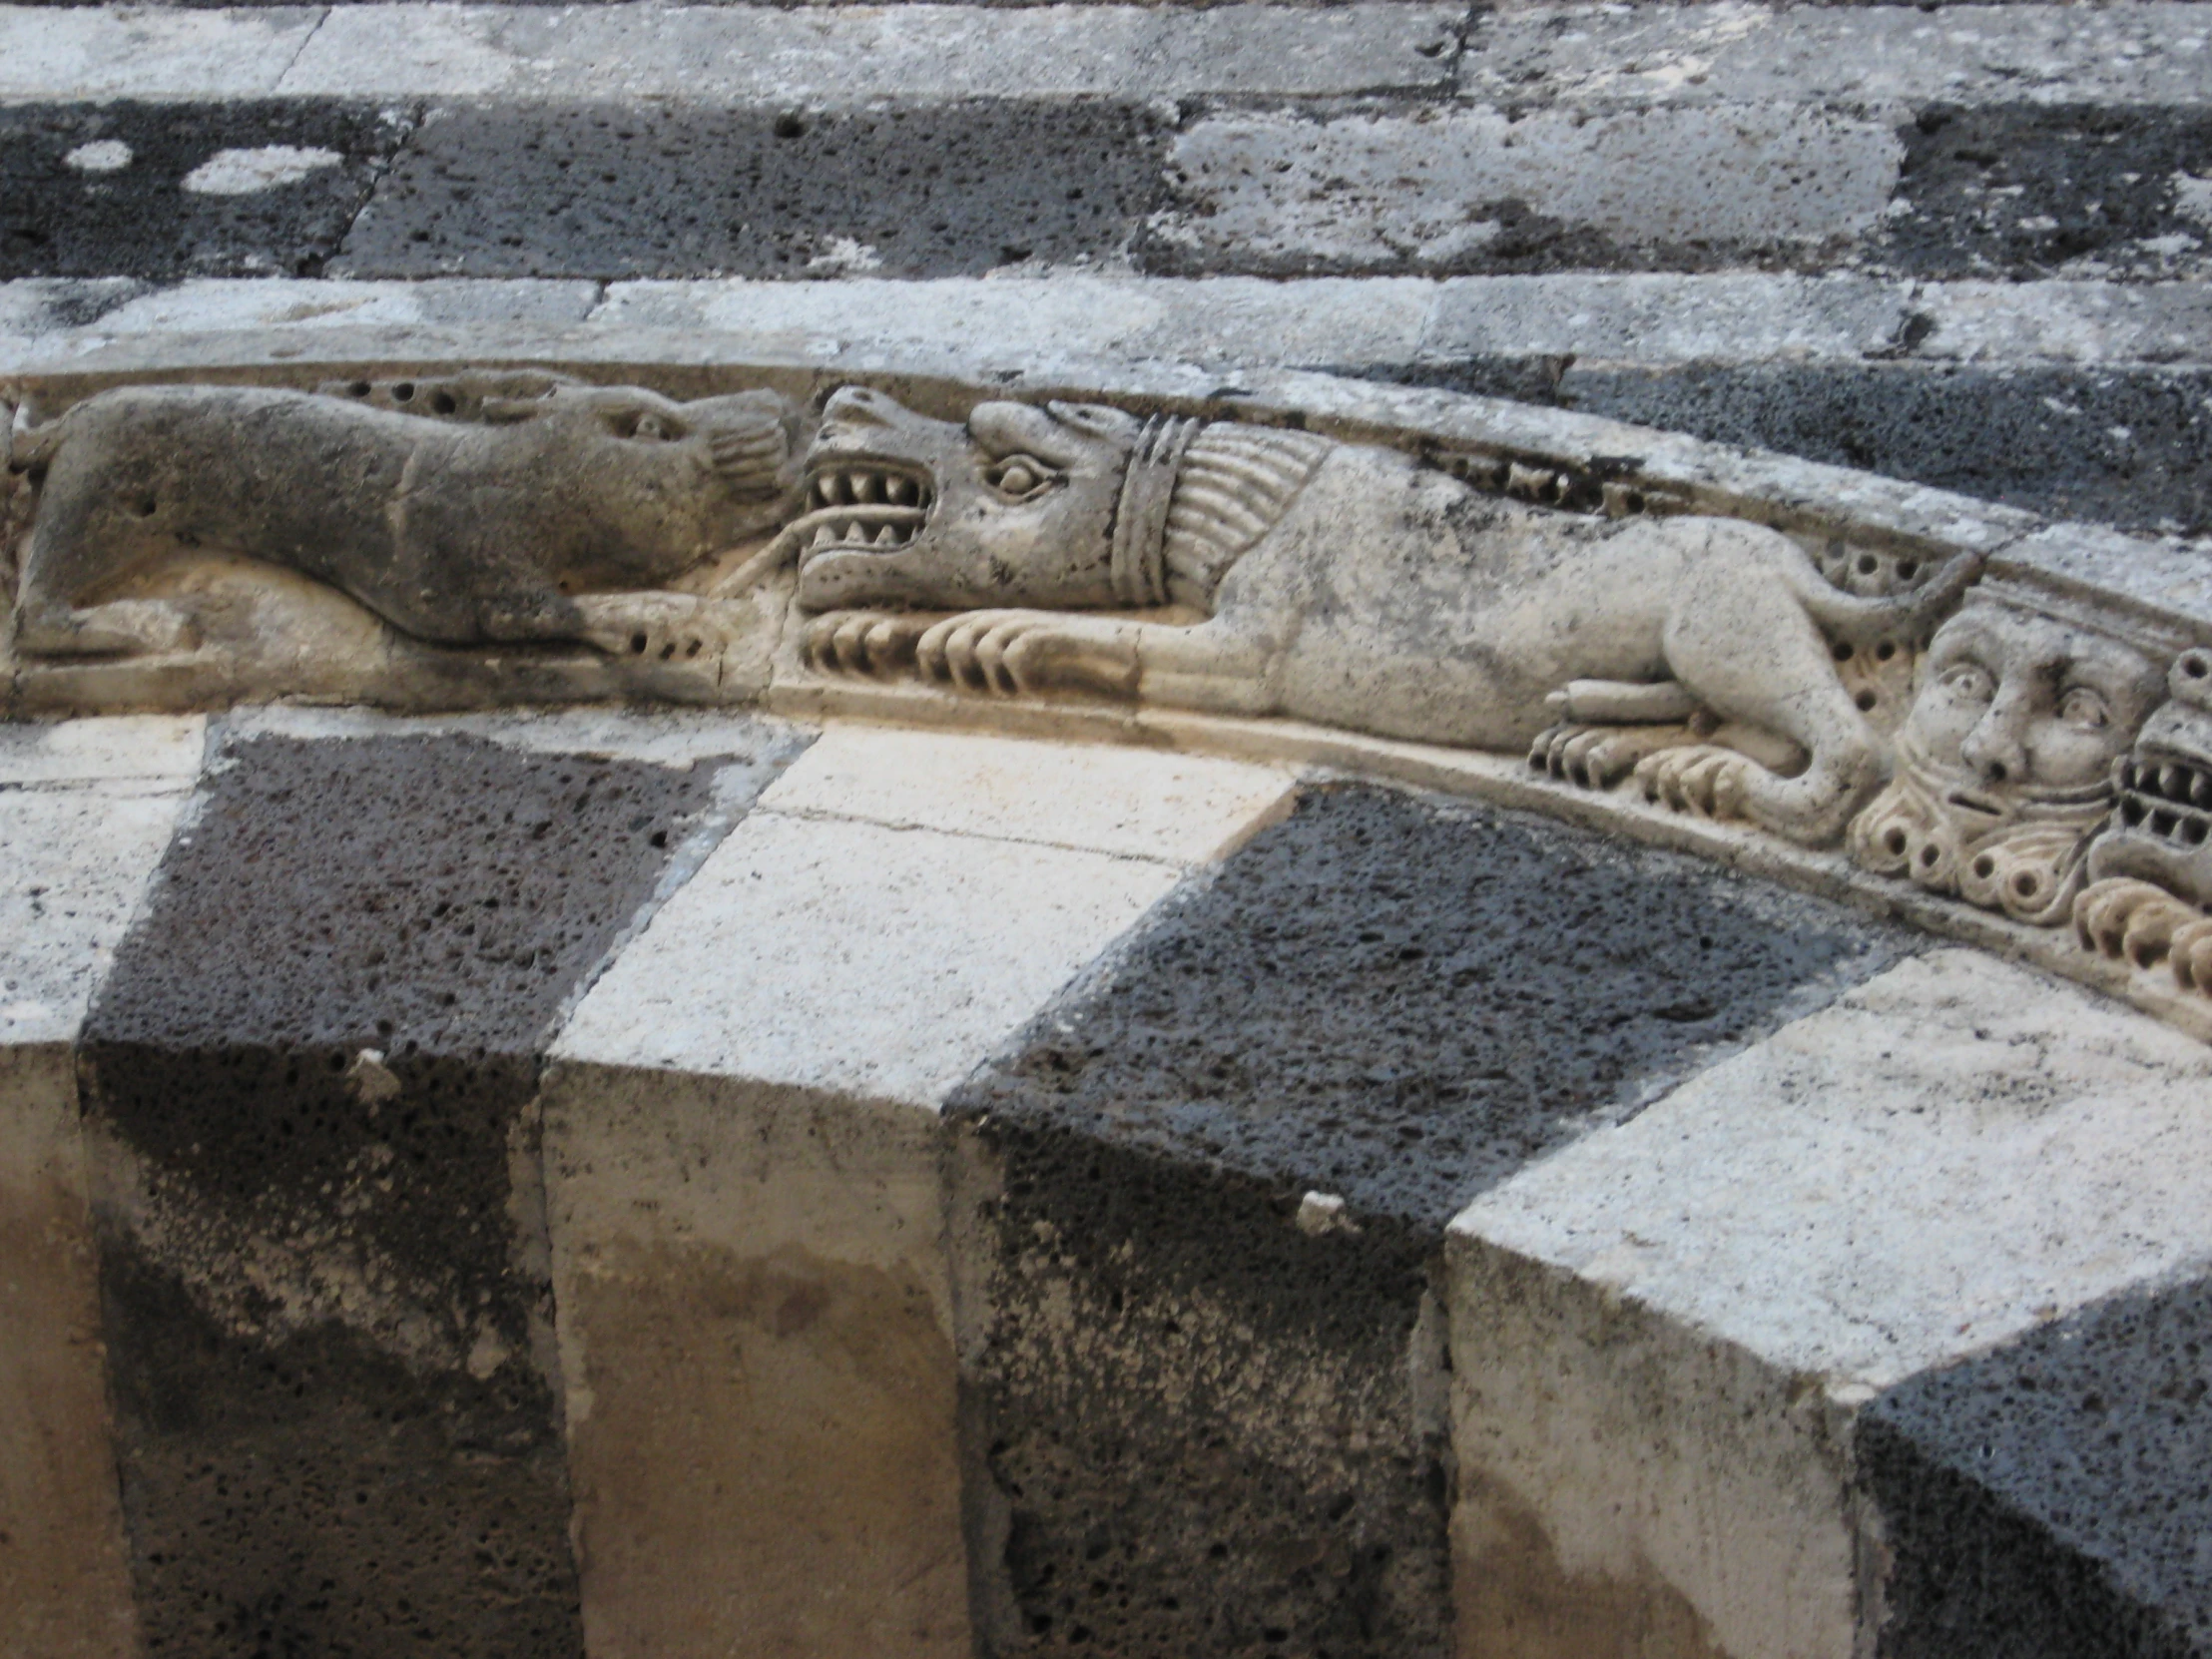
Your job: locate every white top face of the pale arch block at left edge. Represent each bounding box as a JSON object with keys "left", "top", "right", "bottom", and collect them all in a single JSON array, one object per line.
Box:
[{"left": 0, "top": 717, "right": 202, "bottom": 1044}]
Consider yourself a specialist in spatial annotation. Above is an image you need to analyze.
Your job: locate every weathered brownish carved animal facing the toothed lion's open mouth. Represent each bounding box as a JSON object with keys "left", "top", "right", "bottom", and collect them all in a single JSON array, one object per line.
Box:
[{"left": 11, "top": 378, "right": 797, "bottom": 655}]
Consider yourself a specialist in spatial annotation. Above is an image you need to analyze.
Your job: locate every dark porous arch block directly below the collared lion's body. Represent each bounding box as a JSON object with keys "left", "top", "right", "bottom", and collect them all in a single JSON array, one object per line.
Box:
[{"left": 953, "top": 788, "right": 1901, "bottom": 1659}]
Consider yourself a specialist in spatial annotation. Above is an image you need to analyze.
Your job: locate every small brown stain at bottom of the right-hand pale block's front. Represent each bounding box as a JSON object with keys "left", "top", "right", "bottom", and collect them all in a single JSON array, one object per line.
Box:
[{"left": 1451, "top": 1468, "right": 1730, "bottom": 1659}]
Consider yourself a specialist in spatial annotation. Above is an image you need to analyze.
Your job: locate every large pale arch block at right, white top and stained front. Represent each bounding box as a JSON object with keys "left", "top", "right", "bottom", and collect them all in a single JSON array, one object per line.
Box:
[{"left": 1448, "top": 951, "right": 2212, "bottom": 1659}]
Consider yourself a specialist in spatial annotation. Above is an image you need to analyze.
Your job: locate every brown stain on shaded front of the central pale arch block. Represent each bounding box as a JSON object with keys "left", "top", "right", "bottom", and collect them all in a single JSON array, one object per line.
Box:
[{"left": 560, "top": 1239, "right": 969, "bottom": 1659}]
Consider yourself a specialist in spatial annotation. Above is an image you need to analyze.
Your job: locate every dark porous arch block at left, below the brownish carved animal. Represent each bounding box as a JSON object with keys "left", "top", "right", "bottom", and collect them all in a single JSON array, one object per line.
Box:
[{"left": 82, "top": 737, "right": 713, "bottom": 1659}]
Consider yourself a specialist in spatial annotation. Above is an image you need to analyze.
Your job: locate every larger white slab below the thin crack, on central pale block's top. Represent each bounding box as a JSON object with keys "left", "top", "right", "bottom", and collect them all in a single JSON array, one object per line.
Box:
[{"left": 555, "top": 812, "right": 1179, "bottom": 1106}]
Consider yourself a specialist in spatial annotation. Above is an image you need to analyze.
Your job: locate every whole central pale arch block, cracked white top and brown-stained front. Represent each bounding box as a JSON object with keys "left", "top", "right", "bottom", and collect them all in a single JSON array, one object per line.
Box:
[{"left": 544, "top": 728, "right": 1290, "bottom": 1659}]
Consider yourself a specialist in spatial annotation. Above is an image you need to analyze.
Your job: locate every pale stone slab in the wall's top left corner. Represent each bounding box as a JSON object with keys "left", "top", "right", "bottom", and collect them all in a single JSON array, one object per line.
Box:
[{"left": 0, "top": 7, "right": 323, "bottom": 102}]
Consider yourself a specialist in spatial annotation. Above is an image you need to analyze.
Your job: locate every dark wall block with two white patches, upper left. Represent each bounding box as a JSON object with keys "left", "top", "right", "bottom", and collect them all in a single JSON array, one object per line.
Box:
[{"left": 0, "top": 100, "right": 413, "bottom": 280}]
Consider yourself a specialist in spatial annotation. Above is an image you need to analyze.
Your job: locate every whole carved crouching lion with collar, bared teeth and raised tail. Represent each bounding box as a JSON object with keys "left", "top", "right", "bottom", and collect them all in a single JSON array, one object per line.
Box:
[{"left": 781, "top": 389, "right": 1975, "bottom": 842}]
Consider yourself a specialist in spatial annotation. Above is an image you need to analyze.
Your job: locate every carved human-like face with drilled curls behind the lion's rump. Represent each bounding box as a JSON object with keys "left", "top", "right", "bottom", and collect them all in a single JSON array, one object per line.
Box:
[{"left": 1850, "top": 582, "right": 2163, "bottom": 927}]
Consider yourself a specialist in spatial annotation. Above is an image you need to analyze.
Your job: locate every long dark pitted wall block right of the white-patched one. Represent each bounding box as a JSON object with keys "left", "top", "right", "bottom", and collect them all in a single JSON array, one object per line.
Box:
[{"left": 340, "top": 100, "right": 1161, "bottom": 276}]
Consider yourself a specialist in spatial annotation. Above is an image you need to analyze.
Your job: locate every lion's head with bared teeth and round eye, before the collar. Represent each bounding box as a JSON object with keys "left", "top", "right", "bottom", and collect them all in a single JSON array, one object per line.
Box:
[{"left": 792, "top": 387, "right": 1139, "bottom": 611}]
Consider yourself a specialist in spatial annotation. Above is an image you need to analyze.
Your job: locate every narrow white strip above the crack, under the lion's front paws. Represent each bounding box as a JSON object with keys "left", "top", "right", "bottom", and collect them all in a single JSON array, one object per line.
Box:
[{"left": 761, "top": 726, "right": 1297, "bottom": 864}]
